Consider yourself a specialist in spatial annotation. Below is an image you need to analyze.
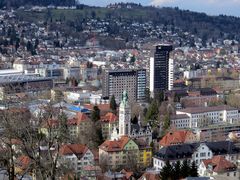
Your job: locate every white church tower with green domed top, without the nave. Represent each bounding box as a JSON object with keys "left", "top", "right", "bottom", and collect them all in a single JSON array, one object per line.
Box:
[{"left": 118, "top": 91, "right": 131, "bottom": 137}]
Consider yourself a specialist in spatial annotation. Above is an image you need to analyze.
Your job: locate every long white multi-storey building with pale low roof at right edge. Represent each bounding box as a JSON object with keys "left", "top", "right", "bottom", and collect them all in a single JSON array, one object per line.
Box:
[{"left": 171, "top": 105, "right": 239, "bottom": 128}]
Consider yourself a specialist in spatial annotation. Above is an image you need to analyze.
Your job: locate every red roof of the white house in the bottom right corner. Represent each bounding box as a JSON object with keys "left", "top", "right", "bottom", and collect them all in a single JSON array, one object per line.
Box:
[{"left": 203, "top": 156, "right": 236, "bottom": 172}]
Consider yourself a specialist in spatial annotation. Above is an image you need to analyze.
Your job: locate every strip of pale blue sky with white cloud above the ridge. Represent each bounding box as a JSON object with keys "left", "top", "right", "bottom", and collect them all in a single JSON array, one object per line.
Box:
[{"left": 80, "top": 0, "right": 240, "bottom": 16}]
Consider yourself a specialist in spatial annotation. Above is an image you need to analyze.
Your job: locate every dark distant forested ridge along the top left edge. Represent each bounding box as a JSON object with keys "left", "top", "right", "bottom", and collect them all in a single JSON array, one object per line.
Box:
[{"left": 0, "top": 0, "right": 76, "bottom": 8}]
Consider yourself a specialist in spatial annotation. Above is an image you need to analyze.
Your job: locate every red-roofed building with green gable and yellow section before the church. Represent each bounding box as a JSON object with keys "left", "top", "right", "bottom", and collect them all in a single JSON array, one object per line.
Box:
[{"left": 99, "top": 136, "right": 152, "bottom": 169}]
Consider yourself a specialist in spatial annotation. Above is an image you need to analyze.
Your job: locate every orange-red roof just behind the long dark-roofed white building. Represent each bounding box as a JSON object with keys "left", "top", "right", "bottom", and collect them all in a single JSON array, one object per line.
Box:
[{"left": 159, "top": 130, "right": 192, "bottom": 146}]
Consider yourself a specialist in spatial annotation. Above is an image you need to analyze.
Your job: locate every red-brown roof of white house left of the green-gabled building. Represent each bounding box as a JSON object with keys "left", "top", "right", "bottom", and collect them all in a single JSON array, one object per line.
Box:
[{"left": 59, "top": 144, "right": 88, "bottom": 157}]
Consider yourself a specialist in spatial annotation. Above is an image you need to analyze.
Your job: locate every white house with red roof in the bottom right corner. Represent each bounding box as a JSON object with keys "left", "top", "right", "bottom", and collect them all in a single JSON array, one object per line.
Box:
[{"left": 198, "top": 155, "right": 240, "bottom": 180}]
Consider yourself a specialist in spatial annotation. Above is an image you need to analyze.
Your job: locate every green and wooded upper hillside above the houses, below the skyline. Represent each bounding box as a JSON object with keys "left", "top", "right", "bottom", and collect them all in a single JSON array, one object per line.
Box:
[{"left": 15, "top": 5, "right": 240, "bottom": 41}]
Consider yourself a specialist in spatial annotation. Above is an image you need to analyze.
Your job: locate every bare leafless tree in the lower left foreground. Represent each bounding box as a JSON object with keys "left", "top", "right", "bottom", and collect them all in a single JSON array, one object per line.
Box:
[{"left": 0, "top": 104, "right": 68, "bottom": 180}]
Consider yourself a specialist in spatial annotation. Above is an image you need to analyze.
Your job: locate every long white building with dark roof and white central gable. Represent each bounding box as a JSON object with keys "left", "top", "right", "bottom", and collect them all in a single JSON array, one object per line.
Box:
[{"left": 153, "top": 141, "right": 240, "bottom": 171}]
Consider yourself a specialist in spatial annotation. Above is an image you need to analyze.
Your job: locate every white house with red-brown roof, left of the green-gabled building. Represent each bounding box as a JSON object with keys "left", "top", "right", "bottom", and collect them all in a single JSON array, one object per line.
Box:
[{"left": 59, "top": 144, "right": 95, "bottom": 172}]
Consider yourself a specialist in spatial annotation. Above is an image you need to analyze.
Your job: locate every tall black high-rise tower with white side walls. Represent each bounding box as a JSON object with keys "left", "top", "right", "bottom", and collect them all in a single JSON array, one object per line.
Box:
[{"left": 150, "top": 44, "right": 173, "bottom": 96}]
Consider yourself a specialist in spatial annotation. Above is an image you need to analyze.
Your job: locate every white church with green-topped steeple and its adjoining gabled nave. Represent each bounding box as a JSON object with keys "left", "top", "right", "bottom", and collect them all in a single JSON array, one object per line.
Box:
[{"left": 111, "top": 91, "right": 152, "bottom": 144}]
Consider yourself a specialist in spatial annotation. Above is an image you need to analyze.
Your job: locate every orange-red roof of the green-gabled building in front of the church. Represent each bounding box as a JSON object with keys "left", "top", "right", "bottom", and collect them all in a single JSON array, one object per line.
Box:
[{"left": 99, "top": 136, "right": 130, "bottom": 152}]
